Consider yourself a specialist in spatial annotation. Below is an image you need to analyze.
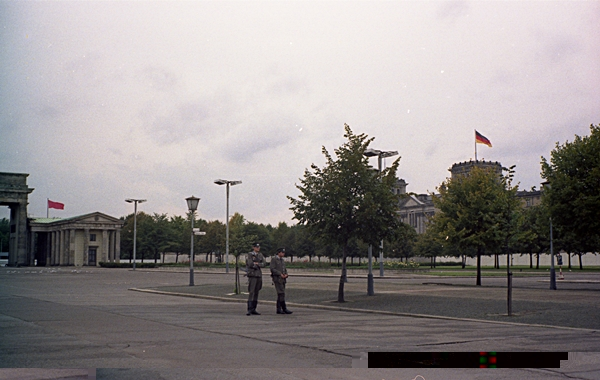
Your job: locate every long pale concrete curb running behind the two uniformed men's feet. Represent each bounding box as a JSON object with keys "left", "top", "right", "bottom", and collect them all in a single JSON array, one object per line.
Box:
[{"left": 129, "top": 288, "right": 600, "bottom": 333}]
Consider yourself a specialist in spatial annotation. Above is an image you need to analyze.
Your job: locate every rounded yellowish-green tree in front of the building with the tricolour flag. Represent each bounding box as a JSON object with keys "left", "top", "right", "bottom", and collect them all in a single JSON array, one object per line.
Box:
[{"left": 430, "top": 167, "right": 520, "bottom": 285}]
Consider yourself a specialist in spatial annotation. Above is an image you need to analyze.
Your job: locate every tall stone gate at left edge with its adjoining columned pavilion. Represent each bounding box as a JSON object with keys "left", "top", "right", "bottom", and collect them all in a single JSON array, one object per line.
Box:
[{"left": 0, "top": 173, "right": 123, "bottom": 266}]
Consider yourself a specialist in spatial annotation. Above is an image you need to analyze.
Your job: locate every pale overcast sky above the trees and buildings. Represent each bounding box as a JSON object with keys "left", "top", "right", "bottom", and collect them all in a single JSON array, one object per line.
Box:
[{"left": 0, "top": 1, "right": 600, "bottom": 224}]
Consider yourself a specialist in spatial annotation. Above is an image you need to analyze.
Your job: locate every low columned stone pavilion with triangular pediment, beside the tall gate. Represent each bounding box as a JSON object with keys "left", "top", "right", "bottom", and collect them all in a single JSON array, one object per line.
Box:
[{"left": 29, "top": 212, "right": 123, "bottom": 266}]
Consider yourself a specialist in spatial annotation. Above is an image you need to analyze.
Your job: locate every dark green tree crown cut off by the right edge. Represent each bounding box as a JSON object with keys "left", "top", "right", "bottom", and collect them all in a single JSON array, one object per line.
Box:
[{"left": 541, "top": 124, "right": 600, "bottom": 252}]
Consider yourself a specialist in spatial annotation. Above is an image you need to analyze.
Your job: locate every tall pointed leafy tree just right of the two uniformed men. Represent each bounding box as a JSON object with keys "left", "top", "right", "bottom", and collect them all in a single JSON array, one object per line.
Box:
[{"left": 288, "top": 124, "right": 400, "bottom": 302}]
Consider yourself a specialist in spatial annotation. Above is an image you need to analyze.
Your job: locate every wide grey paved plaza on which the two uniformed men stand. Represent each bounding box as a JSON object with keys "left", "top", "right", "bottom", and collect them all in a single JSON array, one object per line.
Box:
[{"left": 0, "top": 268, "right": 600, "bottom": 380}]
